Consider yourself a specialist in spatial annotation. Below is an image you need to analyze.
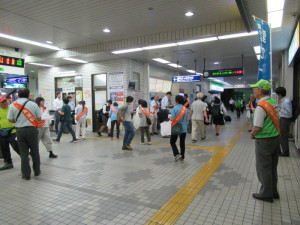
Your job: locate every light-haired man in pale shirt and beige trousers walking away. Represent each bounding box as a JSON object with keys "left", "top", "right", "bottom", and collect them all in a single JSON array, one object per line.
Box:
[{"left": 189, "top": 92, "right": 208, "bottom": 143}]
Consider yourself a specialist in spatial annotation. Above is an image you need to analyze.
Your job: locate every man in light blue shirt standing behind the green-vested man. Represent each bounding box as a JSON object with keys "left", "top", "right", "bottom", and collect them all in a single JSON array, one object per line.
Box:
[{"left": 275, "top": 87, "right": 293, "bottom": 157}]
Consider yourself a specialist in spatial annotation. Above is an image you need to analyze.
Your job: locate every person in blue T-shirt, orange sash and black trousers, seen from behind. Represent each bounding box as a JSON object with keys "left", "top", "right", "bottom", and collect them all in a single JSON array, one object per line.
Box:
[{"left": 170, "top": 95, "right": 188, "bottom": 162}]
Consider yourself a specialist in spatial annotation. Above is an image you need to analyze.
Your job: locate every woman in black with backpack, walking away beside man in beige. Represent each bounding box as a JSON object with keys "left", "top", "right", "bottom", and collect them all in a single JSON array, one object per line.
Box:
[{"left": 211, "top": 97, "right": 227, "bottom": 136}]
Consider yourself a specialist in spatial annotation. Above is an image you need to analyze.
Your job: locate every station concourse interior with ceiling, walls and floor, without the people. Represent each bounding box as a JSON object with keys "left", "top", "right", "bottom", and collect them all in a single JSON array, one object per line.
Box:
[{"left": 0, "top": 0, "right": 300, "bottom": 225}]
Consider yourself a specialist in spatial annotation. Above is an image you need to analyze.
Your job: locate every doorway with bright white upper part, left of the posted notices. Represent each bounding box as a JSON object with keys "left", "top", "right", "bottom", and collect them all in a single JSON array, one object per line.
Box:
[{"left": 92, "top": 73, "right": 107, "bottom": 132}]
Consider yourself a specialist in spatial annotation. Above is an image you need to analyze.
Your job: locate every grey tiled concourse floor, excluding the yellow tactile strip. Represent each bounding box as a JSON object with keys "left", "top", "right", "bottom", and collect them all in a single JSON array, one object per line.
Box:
[{"left": 0, "top": 113, "right": 300, "bottom": 225}]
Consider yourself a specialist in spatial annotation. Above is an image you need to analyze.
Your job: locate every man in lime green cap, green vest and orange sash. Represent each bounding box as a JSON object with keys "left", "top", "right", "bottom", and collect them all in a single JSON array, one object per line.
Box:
[{"left": 251, "top": 80, "right": 280, "bottom": 203}]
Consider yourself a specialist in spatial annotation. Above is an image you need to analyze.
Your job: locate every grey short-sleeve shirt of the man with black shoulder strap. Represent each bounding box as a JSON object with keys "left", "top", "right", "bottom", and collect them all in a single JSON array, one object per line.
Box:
[{"left": 7, "top": 98, "right": 42, "bottom": 128}]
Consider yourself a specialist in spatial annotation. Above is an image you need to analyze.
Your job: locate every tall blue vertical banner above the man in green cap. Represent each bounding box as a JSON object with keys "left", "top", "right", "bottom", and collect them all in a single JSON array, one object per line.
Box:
[{"left": 255, "top": 19, "right": 272, "bottom": 81}]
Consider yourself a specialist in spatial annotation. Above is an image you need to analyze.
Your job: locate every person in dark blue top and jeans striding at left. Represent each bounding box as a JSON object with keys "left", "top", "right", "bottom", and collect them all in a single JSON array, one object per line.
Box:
[{"left": 53, "top": 98, "right": 78, "bottom": 143}]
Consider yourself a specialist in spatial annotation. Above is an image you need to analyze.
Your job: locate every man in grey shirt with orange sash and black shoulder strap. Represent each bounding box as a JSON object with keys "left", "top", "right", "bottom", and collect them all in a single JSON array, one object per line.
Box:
[{"left": 7, "top": 88, "right": 43, "bottom": 180}]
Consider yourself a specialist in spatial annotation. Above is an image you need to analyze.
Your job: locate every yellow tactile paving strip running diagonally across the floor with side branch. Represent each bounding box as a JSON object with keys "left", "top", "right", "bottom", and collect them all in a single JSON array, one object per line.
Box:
[{"left": 145, "top": 124, "right": 247, "bottom": 225}]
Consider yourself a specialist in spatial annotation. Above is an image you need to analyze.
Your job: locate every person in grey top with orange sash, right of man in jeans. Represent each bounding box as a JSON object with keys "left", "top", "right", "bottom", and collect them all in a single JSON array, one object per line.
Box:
[{"left": 138, "top": 100, "right": 151, "bottom": 145}]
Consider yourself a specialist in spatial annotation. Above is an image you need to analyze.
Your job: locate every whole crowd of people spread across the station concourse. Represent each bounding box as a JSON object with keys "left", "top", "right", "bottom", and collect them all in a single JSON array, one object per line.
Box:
[{"left": 0, "top": 80, "right": 297, "bottom": 202}]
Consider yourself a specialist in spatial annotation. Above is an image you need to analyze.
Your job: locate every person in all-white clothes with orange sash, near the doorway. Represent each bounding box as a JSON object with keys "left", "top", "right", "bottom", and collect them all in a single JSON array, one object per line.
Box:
[{"left": 75, "top": 101, "right": 88, "bottom": 140}]
